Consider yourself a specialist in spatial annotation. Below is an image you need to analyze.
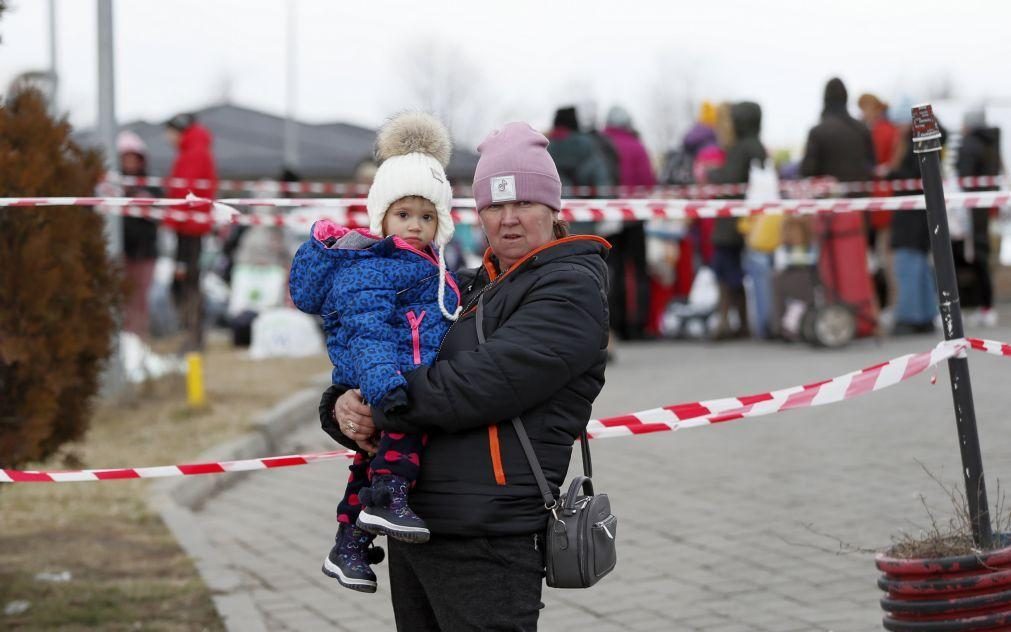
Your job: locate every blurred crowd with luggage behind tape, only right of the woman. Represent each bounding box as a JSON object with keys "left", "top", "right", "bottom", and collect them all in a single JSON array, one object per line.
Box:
[{"left": 529, "top": 79, "right": 1003, "bottom": 347}]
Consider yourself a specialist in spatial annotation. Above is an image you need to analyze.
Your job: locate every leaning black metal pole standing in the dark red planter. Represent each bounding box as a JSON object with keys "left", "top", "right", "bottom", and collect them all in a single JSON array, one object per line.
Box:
[{"left": 913, "top": 104, "right": 993, "bottom": 550}]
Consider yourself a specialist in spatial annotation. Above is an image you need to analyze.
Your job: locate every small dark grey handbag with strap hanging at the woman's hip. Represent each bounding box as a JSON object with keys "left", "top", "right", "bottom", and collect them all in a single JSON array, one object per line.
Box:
[{"left": 476, "top": 296, "right": 618, "bottom": 589}]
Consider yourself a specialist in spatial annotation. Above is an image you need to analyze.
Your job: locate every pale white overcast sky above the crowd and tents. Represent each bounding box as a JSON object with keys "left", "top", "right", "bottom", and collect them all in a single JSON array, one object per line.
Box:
[{"left": 0, "top": 0, "right": 1011, "bottom": 149}]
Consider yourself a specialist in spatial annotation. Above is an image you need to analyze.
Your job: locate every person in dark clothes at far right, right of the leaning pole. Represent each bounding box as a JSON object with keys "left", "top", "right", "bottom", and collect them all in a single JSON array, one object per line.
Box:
[{"left": 951, "top": 109, "right": 1003, "bottom": 327}]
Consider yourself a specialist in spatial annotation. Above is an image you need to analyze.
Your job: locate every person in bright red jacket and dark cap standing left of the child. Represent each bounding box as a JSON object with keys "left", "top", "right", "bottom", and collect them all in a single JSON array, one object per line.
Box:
[{"left": 165, "top": 114, "right": 217, "bottom": 351}]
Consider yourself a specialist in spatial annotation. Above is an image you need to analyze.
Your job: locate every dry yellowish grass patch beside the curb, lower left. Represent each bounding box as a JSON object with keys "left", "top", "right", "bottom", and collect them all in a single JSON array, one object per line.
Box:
[{"left": 0, "top": 345, "right": 330, "bottom": 631}]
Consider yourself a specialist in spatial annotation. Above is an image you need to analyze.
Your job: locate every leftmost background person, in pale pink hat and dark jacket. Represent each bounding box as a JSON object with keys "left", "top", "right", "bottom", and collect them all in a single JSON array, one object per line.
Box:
[{"left": 116, "top": 131, "right": 161, "bottom": 338}]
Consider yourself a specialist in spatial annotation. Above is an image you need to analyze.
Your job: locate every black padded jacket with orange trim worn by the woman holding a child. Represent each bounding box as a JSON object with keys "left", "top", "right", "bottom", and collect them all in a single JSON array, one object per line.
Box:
[{"left": 320, "top": 236, "right": 610, "bottom": 536}]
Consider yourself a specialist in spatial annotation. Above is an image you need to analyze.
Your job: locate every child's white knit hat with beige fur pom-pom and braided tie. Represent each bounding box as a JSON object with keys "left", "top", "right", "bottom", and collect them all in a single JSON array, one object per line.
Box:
[{"left": 366, "top": 112, "right": 460, "bottom": 320}]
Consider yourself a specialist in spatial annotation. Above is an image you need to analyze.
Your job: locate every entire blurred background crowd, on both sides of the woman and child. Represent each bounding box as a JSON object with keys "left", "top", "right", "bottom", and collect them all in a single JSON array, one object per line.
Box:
[{"left": 118, "top": 79, "right": 1003, "bottom": 350}]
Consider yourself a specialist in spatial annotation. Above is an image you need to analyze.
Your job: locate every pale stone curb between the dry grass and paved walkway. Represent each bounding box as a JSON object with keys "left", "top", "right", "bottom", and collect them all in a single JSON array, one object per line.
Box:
[{"left": 148, "top": 373, "right": 330, "bottom": 632}]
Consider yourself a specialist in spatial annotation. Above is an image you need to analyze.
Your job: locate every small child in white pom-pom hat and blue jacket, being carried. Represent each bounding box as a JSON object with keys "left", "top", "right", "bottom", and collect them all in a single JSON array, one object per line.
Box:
[{"left": 289, "top": 113, "right": 460, "bottom": 593}]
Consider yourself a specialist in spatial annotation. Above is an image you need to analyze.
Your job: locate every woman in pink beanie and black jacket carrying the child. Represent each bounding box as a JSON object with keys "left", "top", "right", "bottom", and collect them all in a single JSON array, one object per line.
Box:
[{"left": 319, "top": 123, "right": 608, "bottom": 631}]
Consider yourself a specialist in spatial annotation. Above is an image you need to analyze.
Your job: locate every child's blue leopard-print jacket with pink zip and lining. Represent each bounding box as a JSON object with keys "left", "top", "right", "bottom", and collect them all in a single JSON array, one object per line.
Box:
[{"left": 288, "top": 219, "right": 460, "bottom": 410}]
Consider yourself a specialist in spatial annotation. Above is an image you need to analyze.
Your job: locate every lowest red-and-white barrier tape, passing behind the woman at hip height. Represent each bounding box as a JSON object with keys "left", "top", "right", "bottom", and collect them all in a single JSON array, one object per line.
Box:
[{"left": 0, "top": 338, "right": 1011, "bottom": 482}]
